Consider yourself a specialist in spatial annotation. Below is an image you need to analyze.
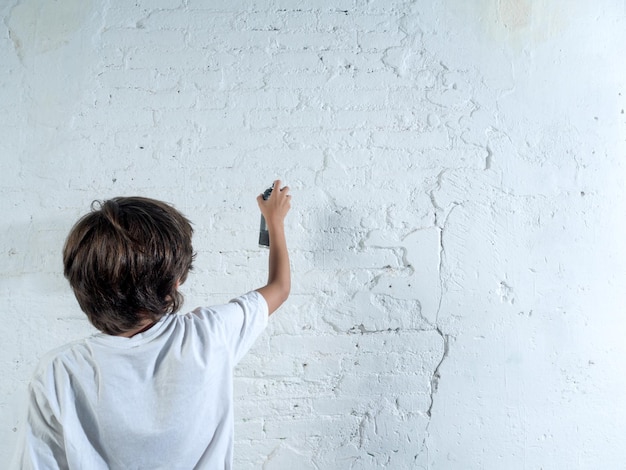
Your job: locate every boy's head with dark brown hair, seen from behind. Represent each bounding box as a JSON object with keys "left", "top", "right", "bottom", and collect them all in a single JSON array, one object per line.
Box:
[{"left": 63, "top": 197, "right": 194, "bottom": 335}]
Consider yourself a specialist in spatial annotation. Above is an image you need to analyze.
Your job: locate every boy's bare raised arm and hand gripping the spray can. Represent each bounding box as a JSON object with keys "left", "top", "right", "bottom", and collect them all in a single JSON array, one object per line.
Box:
[{"left": 257, "top": 180, "right": 291, "bottom": 315}]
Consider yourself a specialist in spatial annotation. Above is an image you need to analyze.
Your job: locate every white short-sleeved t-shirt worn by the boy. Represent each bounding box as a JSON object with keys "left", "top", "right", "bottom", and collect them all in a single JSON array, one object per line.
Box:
[{"left": 15, "top": 292, "right": 268, "bottom": 470}]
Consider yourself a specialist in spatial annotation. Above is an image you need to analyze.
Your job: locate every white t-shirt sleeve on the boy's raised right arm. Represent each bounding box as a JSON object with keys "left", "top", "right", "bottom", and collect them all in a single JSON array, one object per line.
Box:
[{"left": 219, "top": 291, "right": 269, "bottom": 364}]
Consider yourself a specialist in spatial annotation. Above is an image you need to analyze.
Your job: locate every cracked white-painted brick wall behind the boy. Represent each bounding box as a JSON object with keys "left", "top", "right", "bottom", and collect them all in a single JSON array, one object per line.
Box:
[{"left": 0, "top": 0, "right": 626, "bottom": 470}]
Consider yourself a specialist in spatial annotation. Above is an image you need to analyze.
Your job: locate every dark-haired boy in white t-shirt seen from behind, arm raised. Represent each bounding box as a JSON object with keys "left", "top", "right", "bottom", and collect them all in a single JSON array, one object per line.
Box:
[{"left": 15, "top": 180, "right": 291, "bottom": 470}]
